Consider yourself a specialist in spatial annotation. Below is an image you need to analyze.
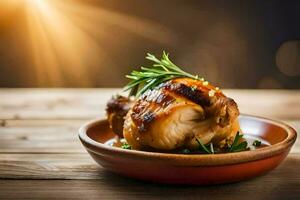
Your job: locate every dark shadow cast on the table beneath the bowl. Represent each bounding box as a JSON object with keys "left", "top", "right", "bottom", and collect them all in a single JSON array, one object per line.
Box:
[{"left": 101, "top": 157, "right": 300, "bottom": 200}]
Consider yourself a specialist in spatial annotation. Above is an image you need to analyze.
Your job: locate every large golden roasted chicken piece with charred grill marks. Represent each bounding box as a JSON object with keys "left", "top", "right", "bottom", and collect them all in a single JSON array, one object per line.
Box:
[{"left": 123, "top": 78, "right": 239, "bottom": 151}]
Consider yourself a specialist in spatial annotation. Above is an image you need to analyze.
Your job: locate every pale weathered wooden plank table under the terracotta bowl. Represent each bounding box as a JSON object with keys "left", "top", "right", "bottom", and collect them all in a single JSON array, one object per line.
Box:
[{"left": 0, "top": 89, "right": 300, "bottom": 200}]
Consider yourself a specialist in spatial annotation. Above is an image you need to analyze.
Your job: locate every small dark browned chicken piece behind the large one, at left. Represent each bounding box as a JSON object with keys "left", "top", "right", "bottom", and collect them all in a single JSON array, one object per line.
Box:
[{"left": 106, "top": 95, "right": 133, "bottom": 138}]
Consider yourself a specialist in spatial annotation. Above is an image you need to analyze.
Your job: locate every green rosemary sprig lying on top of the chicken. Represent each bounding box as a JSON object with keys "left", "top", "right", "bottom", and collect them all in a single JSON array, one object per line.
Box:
[{"left": 124, "top": 51, "right": 199, "bottom": 97}]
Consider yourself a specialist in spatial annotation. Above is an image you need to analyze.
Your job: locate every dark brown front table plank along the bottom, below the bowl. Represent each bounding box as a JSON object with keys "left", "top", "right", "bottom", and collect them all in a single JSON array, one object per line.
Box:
[{"left": 0, "top": 166, "right": 300, "bottom": 200}]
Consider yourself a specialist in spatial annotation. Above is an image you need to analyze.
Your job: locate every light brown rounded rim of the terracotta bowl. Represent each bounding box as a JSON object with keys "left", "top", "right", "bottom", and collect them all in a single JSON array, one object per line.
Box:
[{"left": 79, "top": 114, "right": 297, "bottom": 166}]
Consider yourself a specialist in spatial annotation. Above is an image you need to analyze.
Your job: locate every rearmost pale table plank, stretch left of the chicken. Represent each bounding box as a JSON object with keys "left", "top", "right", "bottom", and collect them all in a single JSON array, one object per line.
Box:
[{"left": 0, "top": 89, "right": 122, "bottom": 119}]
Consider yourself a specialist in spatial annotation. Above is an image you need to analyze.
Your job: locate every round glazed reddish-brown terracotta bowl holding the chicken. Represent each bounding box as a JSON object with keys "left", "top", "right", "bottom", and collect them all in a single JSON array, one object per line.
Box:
[{"left": 79, "top": 115, "right": 297, "bottom": 185}]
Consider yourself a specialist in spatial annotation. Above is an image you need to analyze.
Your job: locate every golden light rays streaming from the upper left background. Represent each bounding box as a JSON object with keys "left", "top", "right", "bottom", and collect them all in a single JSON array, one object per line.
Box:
[{"left": 0, "top": 0, "right": 175, "bottom": 87}]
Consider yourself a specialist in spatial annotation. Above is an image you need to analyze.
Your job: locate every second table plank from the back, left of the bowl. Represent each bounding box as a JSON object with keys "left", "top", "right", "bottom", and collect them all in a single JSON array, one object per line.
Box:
[{"left": 0, "top": 120, "right": 85, "bottom": 153}]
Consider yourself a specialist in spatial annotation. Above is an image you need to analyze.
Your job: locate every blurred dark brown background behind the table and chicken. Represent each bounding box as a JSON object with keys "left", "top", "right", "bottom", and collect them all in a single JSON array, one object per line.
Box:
[{"left": 0, "top": 0, "right": 300, "bottom": 89}]
